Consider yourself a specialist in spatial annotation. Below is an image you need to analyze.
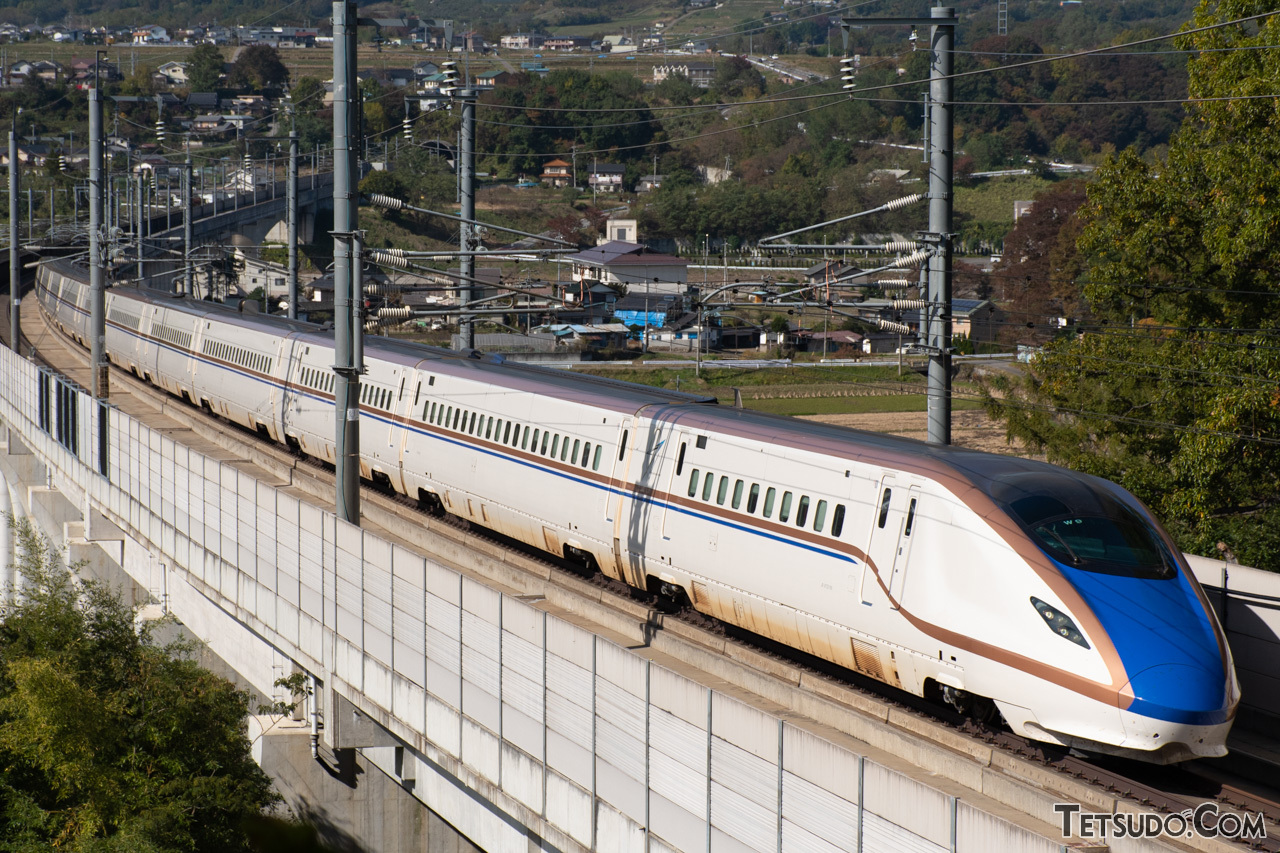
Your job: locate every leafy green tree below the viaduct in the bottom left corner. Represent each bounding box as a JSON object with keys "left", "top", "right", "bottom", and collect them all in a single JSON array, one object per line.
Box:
[{"left": 0, "top": 520, "right": 278, "bottom": 852}]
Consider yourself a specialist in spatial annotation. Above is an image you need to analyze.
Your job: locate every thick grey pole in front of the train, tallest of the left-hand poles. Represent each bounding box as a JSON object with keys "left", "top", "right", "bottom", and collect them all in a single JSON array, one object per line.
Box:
[{"left": 333, "top": 0, "right": 364, "bottom": 525}]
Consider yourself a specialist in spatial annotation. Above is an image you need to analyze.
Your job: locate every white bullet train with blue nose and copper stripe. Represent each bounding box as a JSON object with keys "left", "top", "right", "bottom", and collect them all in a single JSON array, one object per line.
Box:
[{"left": 38, "top": 264, "right": 1239, "bottom": 762}]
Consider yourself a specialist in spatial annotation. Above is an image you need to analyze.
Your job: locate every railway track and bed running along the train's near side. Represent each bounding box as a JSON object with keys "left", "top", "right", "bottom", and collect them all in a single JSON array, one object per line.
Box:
[{"left": 32, "top": 306, "right": 1280, "bottom": 853}]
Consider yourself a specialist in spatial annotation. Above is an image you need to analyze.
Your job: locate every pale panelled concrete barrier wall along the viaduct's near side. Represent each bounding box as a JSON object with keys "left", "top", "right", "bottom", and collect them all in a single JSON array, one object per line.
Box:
[{"left": 0, "top": 350, "right": 1090, "bottom": 853}]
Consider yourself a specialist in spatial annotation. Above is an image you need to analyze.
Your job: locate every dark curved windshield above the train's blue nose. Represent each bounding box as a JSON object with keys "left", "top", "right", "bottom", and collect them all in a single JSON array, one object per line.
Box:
[{"left": 992, "top": 474, "right": 1178, "bottom": 579}]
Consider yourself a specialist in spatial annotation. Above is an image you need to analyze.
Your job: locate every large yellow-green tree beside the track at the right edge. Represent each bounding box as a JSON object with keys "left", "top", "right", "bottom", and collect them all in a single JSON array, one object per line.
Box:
[{"left": 989, "top": 0, "right": 1280, "bottom": 570}]
